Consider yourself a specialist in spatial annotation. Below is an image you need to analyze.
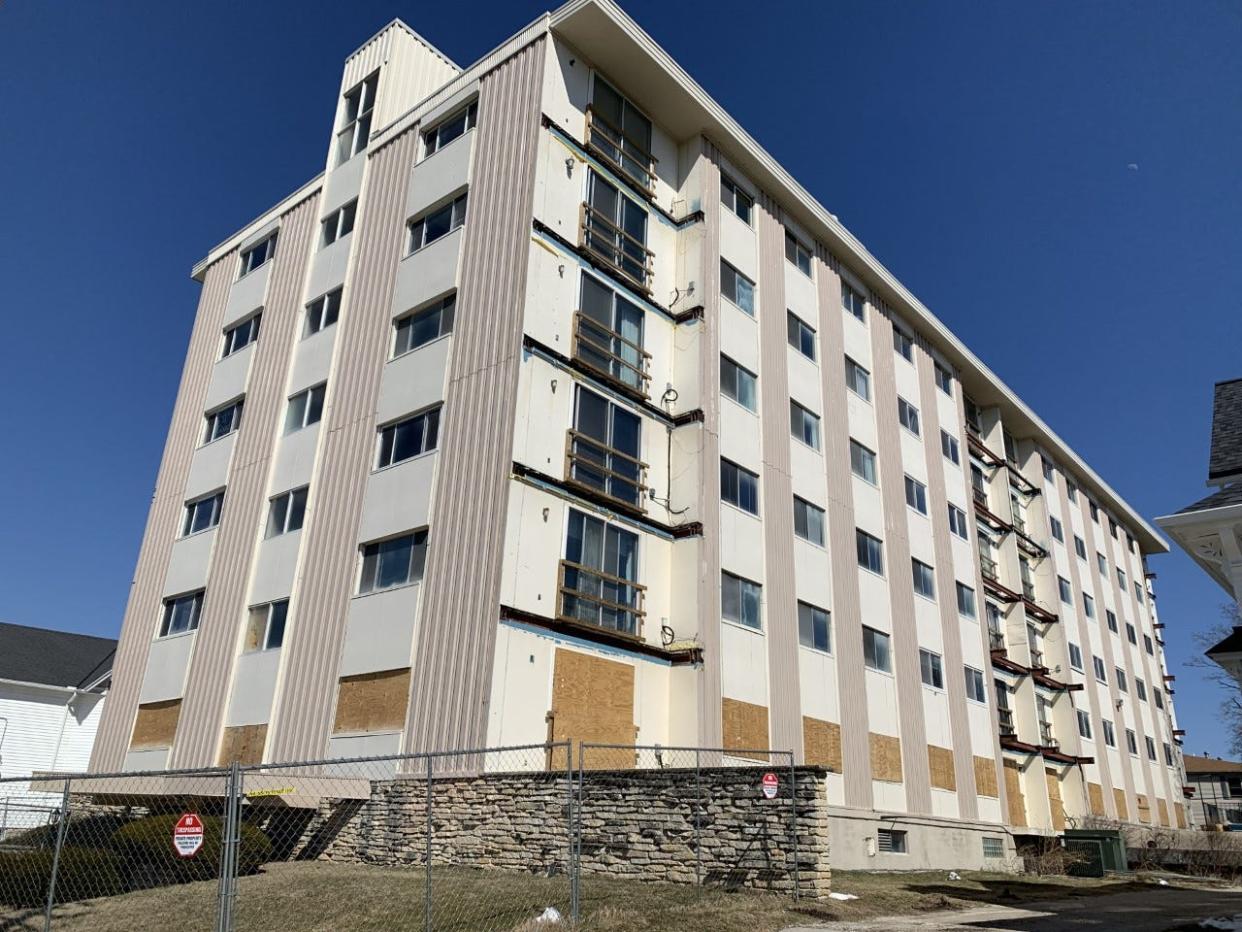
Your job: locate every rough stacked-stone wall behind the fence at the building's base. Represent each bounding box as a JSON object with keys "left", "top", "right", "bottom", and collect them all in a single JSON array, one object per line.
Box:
[{"left": 268, "top": 767, "right": 831, "bottom": 897}]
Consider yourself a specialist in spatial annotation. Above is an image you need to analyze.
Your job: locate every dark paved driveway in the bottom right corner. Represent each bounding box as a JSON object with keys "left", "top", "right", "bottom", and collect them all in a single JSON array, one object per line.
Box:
[{"left": 785, "top": 887, "right": 1242, "bottom": 932}]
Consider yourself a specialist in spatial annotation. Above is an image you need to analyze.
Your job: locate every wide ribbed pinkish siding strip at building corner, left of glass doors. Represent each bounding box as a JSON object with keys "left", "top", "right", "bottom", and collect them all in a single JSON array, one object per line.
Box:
[{"left": 405, "top": 39, "right": 545, "bottom": 751}]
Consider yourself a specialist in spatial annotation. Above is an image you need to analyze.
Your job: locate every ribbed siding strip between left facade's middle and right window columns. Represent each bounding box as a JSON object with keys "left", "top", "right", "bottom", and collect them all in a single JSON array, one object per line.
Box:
[{"left": 267, "top": 127, "right": 417, "bottom": 761}]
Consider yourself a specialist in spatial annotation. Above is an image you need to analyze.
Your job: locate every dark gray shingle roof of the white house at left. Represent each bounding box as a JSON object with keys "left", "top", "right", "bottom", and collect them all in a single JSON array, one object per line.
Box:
[{"left": 0, "top": 621, "right": 117, "bottom": 686}]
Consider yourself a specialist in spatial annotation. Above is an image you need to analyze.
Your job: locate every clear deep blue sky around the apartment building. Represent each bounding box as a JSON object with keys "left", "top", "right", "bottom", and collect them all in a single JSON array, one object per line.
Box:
[{"left": 0, "top": 0, "right": 1242, "bottom": 753}]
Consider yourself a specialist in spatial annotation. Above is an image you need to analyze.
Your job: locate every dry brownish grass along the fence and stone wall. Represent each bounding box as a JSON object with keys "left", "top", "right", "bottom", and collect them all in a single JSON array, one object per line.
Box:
[{"left": 0, "top": 862, "right": 1192, "bottom": 932}]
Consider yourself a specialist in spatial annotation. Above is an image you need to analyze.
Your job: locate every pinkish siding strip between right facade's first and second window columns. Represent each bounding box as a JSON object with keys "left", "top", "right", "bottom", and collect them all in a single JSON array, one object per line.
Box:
[{"left": 750, "top": 195, "right": 799, "bottom": 761}]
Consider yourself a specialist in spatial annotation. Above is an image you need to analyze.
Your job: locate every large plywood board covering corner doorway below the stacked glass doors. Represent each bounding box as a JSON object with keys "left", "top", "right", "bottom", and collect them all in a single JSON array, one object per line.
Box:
[{"left": 549, "top": 647, "right": 638, "bottom": 770}]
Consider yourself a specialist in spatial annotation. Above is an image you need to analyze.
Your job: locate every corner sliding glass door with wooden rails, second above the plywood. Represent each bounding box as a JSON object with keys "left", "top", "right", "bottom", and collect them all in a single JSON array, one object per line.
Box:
[{"left": 569, "top": 386, "right": 646, "bottom": 507}]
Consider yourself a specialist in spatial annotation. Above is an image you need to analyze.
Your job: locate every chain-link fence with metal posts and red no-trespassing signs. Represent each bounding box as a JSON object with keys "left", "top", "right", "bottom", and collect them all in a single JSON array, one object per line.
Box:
[{"left": 0, "top": 743, "right": 827, "bottom": 932}]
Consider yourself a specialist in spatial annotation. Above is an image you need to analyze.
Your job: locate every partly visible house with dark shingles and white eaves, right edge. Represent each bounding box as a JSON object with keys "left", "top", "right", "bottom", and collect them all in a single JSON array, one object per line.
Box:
[{"left": 1156, "top": 379, "right": 1242, "bottom": 683}]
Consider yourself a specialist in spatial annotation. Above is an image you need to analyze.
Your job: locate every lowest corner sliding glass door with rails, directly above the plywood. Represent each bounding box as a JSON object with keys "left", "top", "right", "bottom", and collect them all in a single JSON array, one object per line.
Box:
[{"left": 560, "top": 508, "right": 643, "bottom": 636}]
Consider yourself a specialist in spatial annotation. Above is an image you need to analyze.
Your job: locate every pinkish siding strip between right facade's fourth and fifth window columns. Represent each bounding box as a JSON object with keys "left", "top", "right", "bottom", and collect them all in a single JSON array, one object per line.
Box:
[{"left": 914, "top": 347, "right": 978, "bottom": 819}]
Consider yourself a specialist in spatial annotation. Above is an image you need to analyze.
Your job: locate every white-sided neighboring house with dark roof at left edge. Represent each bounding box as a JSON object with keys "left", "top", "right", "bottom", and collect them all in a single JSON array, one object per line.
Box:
[{"left": 0, "top": 623, "right": 117, "bottom": 839}]
